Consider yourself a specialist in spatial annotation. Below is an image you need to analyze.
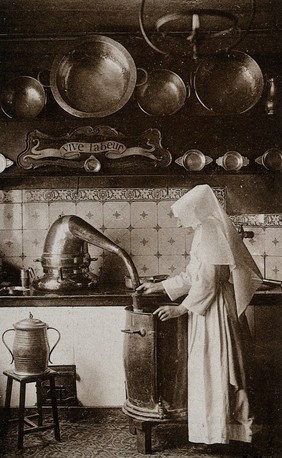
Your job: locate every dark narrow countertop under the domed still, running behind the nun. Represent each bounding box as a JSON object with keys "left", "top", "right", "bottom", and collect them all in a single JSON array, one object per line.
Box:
[{"left": 0, "top": 285, "right": 282, "bottom": 308}]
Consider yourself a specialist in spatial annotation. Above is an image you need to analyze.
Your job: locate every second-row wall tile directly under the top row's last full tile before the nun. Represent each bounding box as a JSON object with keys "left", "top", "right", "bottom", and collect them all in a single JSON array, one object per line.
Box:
[{"left": 131, "top": 228, "right": 158, "bottom": 255}]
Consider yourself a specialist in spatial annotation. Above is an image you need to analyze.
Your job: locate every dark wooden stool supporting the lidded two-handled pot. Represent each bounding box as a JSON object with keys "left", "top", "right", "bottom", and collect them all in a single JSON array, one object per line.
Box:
[{"left": 3, "top": 369, "right": 60, "bottom": 449}]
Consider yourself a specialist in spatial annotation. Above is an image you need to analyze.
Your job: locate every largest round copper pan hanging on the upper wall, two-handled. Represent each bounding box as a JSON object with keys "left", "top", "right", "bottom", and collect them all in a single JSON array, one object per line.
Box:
[{"left": 50, "top": 35, "right": 139, "bottom": 118}]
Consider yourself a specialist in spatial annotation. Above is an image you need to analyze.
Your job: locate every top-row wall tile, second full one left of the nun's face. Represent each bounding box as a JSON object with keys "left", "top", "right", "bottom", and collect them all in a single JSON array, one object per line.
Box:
[{"left": 104, "top": 202, "right": 130, "bottom": 228}]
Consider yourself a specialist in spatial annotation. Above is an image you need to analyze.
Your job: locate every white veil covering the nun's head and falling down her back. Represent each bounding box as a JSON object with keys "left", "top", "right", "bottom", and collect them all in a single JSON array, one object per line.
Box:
[{"left": 171, "top": 184, "right": 262, "bottom": 317}]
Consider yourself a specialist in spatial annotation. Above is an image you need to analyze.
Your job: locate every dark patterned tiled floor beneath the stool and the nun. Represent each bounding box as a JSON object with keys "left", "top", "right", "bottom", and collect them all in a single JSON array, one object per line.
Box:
[{"left": 0, "top": 408, "right": 282, "bottom": 458}]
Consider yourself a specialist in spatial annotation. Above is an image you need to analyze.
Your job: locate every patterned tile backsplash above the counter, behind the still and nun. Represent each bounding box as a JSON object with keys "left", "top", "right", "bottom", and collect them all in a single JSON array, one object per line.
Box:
[{"left": 0, "top": 188, "right": 282, "bottom": 281}]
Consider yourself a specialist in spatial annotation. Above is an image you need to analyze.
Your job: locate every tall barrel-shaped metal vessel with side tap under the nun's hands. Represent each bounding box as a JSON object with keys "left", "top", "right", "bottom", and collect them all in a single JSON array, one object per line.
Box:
[{"left": 122, "top": 305, "right": 188, "bottom": 422}]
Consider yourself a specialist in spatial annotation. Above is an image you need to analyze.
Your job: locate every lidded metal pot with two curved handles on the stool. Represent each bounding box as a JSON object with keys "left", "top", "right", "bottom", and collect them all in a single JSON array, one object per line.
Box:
[{"left": 2, "top": 313, "right": 61, "bottom": 375}]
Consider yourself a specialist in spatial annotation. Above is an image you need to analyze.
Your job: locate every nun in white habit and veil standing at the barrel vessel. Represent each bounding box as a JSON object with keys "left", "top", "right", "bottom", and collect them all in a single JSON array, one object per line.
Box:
[{"left": 138, "top": 185, "right": 262, "bottom": 444}]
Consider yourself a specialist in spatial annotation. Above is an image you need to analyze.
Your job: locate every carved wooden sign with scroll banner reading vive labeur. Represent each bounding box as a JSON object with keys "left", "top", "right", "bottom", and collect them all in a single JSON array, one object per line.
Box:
[{"left": 17, "top": 126, "right": 172, "bottom": 172}]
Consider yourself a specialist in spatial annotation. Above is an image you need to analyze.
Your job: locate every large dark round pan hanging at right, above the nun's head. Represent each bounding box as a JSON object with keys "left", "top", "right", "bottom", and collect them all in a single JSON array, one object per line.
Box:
[{"left": 194, "top": 51, "right": 264, "bottom": 115}]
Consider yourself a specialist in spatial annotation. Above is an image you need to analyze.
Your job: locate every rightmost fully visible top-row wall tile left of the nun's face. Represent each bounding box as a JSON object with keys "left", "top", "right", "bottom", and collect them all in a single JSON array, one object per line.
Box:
[{"left": 131, "top": 202, "right": 158, "bottom": 227}]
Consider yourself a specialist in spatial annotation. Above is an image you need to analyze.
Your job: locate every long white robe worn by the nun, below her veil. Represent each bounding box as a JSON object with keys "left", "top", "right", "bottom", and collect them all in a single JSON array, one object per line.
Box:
[{"left": 163, "top": 229, "right": 253, "bottom": 444}]
